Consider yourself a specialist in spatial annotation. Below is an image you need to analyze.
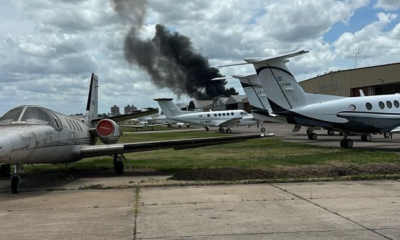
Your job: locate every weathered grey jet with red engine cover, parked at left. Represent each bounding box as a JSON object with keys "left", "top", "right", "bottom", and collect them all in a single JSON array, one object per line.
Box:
[{"left": 0, "top": 74, "right": 272, "bottom": 194}]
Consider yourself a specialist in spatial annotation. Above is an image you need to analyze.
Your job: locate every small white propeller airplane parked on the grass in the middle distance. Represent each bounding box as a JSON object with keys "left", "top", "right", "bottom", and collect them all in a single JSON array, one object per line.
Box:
[{"left": 154, "top": 98, "right": 258, "bottom": 133}]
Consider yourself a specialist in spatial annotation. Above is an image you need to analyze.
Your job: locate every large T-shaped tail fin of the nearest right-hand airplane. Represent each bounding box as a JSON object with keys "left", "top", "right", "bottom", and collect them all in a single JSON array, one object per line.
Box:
[{"left": 244, "top": 51, "right": 311, "bottom": 114}]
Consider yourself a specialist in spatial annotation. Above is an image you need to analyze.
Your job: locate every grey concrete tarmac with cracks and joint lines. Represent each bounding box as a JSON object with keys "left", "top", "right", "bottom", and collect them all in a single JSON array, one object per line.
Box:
[{"left": 0, "top": 124, "right": 400, "bottom": 240}]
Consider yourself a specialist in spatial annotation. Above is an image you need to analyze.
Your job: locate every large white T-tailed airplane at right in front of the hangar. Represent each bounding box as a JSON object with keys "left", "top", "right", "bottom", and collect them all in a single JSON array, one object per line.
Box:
[{"left": 218, "top": 50, "right": 400, "bottom": 148}]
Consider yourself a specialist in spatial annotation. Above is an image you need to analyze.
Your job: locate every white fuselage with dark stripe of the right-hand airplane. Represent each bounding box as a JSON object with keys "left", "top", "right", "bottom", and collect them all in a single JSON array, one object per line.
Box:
[{"left": 274, "top": 94, "right": 400, "bottom": 133}]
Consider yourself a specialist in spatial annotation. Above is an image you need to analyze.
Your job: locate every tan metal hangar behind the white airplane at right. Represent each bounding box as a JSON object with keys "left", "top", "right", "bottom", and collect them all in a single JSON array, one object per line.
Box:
[{"left": 300, "top": 63, "right": 400, "bottom": 97}]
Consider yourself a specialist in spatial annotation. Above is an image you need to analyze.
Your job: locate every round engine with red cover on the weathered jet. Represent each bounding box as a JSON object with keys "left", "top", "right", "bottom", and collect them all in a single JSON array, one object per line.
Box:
[{"left": 96, "top": 119, "right": 122, "bottom": 144}]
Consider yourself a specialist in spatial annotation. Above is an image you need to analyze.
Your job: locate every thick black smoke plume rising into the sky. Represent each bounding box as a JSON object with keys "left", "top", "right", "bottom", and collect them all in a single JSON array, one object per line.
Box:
[{"left": 113, "top": 0, "right": 238, "bottom": 99}]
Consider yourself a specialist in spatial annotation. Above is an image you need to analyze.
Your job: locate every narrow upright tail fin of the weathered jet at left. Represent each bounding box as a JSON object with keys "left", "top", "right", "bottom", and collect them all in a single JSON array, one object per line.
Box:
[{"left": 85, "top": 73, "right": 99, "bottom": 127}]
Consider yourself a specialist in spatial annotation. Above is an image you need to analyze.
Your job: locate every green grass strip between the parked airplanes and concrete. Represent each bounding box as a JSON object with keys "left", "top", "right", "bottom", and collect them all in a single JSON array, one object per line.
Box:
[{"left": 27, "top": 131, "right": 400, "bottom": 172}]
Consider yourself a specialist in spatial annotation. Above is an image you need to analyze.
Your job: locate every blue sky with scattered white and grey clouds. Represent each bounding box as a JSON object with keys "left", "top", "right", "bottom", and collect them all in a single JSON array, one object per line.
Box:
[{"left": 0, "top": 0, "right": 400, "bottom": 115}]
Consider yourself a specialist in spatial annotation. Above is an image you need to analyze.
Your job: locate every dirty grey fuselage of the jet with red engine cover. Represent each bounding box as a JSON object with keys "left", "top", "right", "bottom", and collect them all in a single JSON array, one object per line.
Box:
[{"left": 0, "top": 110, "right": 96, "bottom": 164}]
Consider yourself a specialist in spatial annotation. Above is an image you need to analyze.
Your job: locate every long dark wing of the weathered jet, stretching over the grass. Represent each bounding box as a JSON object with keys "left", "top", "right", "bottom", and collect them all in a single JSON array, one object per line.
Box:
[{"left": 80, "top": 134, "right": 274, "bottom": 158}]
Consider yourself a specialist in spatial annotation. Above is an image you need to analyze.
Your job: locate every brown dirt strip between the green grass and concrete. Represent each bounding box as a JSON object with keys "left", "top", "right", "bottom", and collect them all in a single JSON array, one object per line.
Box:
[{"left": 172, "top": 163, "right": 400, "bottom": 181}]
